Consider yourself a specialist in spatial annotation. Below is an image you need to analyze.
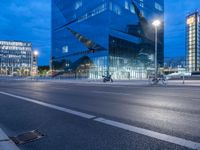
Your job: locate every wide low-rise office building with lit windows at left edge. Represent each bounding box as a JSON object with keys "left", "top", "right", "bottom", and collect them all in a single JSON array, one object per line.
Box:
[{"left": 0, "top": 41, "right": 32, "bottom": 75}]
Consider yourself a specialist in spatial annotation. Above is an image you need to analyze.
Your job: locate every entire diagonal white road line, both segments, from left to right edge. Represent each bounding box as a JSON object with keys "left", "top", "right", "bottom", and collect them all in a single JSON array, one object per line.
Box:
[{"left": 0, "top": 92, "right": 200, "bottom": 150}]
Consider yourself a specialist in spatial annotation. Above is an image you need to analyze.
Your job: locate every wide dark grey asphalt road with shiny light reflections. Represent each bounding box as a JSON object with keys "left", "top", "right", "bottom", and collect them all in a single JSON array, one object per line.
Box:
[{"left": 0, "top": 81, "right": 200, "bottom": 150}]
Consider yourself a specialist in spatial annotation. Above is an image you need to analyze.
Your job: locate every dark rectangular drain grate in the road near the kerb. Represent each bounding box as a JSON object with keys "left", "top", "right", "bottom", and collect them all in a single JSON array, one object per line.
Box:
[{"left": 10, "top": 130, "right": 45, "bottom": 145}]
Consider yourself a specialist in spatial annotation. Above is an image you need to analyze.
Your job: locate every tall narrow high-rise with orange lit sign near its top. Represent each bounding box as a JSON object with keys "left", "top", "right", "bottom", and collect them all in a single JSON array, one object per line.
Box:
[{"left": 186, "top": 11, "right": 200, "bottom": 72}]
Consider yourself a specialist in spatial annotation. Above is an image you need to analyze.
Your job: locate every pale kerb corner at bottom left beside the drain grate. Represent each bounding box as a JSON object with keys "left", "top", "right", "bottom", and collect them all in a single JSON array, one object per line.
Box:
[{"left": 0, "top": 128, "right": 19, "bottom": 150}]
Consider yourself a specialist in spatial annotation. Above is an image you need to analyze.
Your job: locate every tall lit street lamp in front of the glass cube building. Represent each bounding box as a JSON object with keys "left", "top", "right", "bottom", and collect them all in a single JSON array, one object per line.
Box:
[{"left": 152, "top": 20, "right": 161, "bottom": 78}]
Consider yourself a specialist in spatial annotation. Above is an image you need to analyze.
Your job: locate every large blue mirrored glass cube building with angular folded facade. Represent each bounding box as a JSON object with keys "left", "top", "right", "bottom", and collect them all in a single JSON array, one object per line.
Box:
[{"left": 52, "top": 0, "right": 164, "bottom": 79}]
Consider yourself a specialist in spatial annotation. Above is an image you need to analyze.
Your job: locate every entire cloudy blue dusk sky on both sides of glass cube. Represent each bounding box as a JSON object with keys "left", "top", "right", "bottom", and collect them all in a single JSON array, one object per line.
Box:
[{"left": 0, "top": 0, "right": 200, "bottom": 65}]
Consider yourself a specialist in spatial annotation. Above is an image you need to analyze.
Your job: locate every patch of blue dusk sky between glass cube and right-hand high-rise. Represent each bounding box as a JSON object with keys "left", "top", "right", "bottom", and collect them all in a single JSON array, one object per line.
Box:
[{"left": 165, "top": 0, "right": 200, "bottom": 57}]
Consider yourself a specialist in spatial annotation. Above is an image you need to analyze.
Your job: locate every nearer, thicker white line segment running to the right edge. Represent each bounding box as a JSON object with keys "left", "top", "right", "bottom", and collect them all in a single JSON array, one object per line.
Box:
[{"left": 94, "top": 118, "right": 200, "bottom": 150}]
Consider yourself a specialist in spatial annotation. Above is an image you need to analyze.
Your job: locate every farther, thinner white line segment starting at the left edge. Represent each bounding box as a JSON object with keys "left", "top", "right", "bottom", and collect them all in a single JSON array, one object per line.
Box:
[{"left": 0, "top": 92, "right": 96, "bottom": 119}]
